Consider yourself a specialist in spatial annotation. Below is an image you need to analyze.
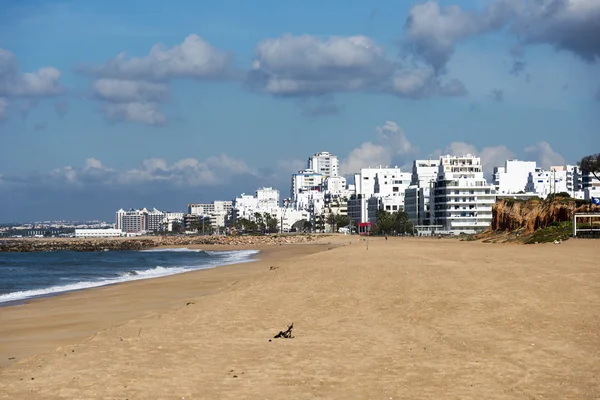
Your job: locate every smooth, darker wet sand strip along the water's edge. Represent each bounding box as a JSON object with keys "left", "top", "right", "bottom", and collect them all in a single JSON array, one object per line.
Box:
[{"left": 0, "top": 241, "right": 335, "bottom": 371}]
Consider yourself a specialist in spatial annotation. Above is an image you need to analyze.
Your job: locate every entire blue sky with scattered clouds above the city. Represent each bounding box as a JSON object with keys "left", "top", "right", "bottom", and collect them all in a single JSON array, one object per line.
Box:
[{"left": 0, "top": 0, "right": 600, "bottom": 222}]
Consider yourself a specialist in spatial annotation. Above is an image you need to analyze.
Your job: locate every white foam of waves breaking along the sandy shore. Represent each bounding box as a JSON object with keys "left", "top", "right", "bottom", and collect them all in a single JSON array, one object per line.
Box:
[{"left": 0, "top": 250, "right": 259, "bottom": 303}]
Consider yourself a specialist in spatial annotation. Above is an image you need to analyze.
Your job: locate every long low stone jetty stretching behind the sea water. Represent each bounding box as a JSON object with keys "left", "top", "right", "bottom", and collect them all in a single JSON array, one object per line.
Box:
[{"left": 0, "top": 234, "right": 319, "bottom": 252}]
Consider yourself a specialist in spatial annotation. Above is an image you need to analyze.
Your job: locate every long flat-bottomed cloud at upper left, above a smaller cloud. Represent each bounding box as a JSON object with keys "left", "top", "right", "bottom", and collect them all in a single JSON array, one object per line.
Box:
[{"left": 82, "top": 34, "right": 231, "bottom": 81}]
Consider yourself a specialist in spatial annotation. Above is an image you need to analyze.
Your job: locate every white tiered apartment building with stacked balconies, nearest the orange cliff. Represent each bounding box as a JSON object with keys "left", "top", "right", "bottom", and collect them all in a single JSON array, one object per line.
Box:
[{"left": 432, "top": 154, "right": 496, "bottom": 234}]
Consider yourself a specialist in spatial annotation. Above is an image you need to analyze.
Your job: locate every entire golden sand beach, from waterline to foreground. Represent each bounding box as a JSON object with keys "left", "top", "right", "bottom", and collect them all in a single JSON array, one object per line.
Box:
[{"left": 0, "top": 236, "right": 600, "bottom": 399}]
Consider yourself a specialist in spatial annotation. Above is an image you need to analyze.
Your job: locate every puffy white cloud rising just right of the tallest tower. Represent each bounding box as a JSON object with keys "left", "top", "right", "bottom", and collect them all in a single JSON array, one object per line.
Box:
[{"left": 340, "top": 121, "right": 416, "bottom": 175}]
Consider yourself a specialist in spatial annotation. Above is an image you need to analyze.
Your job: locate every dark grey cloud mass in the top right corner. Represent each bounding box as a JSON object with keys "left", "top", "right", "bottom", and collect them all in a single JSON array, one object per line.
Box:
[{"left": 402, "top": 0, "right": 600, "bottom": 74}]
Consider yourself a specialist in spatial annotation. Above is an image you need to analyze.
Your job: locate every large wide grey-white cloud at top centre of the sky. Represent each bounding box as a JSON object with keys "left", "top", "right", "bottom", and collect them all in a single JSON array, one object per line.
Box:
[{"left": 248, "top": 35, "right": 466, "bottom": 98}]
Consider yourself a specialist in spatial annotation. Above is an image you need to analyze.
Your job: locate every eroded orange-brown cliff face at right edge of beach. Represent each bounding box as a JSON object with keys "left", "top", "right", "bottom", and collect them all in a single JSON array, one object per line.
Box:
[{"left": 491, "top": 199, "right": 600, "bottom": 233}]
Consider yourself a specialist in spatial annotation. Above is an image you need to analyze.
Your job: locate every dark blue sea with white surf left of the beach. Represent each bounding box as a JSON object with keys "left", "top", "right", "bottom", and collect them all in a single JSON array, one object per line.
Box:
[{"left": 0, "top": 248, "right": 258, "bottom": 305}]
